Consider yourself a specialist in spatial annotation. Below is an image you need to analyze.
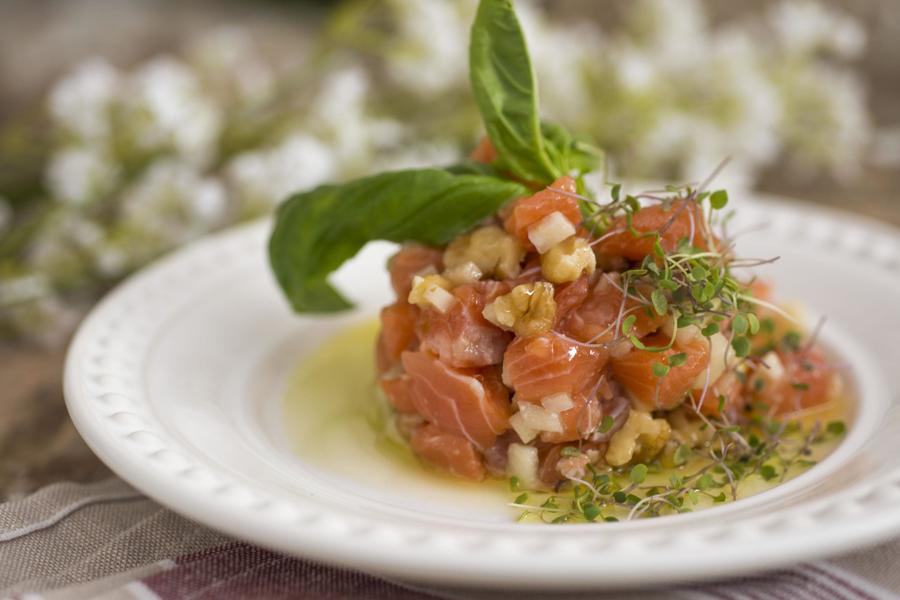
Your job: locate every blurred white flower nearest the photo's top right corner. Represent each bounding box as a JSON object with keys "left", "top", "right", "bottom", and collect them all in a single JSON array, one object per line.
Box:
[{"left": 769, "top": 0, "right": 866, "bottom": 59}]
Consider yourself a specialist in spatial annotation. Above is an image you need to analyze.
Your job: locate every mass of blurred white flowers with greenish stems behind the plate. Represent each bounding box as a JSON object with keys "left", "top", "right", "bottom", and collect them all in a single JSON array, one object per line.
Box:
[{"left": 0, "top": 0, "right": 876, "bottom": 344}]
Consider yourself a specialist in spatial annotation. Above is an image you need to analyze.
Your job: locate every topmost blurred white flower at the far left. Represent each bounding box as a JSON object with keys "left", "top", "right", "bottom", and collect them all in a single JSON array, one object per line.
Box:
[{"left": 48, "top": 58, "right": 120, "bottom": 141}]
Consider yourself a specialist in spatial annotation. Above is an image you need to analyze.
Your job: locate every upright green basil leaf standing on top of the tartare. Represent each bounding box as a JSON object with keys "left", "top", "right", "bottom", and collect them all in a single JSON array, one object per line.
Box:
[{"left": 469, "top": 0, "right": 564, "bottom": 185}]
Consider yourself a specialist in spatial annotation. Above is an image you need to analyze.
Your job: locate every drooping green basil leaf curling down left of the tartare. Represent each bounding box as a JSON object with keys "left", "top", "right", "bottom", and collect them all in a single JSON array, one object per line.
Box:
[{"left": 269, "top": 169, "right": 529, "bottom": 312}]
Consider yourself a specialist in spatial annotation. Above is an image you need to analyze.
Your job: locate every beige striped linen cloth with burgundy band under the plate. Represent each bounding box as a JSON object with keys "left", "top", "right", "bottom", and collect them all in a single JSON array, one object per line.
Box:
[{"left": 0, "top": 479, "right": 900, "bottom": 600}]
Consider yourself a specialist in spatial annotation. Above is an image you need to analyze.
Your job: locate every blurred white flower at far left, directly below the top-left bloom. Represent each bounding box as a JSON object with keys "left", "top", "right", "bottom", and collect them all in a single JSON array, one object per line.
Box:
[{"left": 45, "top": 146, "right": 119, "bottom": 204}]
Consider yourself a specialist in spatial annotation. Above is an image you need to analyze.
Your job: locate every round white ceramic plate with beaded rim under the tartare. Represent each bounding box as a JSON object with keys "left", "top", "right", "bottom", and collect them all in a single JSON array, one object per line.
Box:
[{"left": 65, "top": 202, "right": 900, "bottom": 589}]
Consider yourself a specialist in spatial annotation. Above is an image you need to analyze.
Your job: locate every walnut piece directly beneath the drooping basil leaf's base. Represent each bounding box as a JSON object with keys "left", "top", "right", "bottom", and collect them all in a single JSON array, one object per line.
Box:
[{"left": 444, "top": 225, "right": 525, "bottom": 279}]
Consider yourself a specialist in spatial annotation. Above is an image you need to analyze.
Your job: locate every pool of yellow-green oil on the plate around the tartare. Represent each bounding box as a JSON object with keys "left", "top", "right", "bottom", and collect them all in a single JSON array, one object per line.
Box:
[{"left": 284, "top": 320, "right": 850, "bottom": 520}]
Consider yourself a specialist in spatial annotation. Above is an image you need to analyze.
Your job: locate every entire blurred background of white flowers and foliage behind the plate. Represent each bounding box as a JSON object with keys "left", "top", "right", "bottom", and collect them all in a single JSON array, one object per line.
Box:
[{"left": 0, "top": 0, "right": 900, "bottom": 344}]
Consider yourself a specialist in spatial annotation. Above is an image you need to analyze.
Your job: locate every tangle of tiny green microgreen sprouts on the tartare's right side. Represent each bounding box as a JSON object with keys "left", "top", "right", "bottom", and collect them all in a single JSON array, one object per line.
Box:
[{"left": 514, "top": 170, "right": 846, "bottom": 523}]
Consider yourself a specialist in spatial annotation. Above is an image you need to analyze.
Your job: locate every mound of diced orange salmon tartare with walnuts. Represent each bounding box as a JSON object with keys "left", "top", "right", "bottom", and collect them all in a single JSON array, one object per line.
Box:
[{"left": 376, "top": 141, "right": 835, "bottom": 489}]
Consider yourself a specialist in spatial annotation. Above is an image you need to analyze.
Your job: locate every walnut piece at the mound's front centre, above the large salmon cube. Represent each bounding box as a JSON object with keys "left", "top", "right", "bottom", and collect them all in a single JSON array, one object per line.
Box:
[{"left": 482, "top": 281, "right": 556, "bottom": 336}]
